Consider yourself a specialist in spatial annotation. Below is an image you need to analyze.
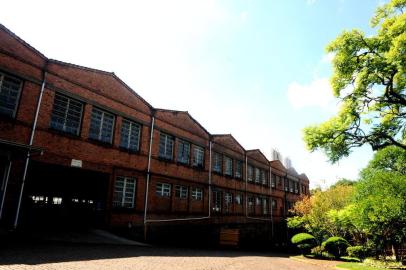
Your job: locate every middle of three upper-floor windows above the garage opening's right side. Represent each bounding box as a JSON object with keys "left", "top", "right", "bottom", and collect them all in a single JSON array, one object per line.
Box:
[{"left": 89, "top": 108, "right": 114, "bottom": 143}]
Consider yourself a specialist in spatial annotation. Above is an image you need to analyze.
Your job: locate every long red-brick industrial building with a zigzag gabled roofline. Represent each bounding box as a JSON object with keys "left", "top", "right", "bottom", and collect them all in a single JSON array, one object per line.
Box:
[{"left": 0, "top": 25, "right": 309, "bottom": 246}]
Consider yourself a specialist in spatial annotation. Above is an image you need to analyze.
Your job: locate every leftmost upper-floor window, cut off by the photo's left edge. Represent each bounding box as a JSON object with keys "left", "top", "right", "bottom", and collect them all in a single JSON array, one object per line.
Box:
[{"left": 0, "top": 73, "right": 22, "bottom": 117}]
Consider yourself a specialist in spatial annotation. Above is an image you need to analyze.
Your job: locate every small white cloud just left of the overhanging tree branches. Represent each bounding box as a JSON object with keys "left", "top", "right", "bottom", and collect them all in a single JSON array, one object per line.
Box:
[{"left": 288, "top": 78, "right": 337, "bottom": 110}]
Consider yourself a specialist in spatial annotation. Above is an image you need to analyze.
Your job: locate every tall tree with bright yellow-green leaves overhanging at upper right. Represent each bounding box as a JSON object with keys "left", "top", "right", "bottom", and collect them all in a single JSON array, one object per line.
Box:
[{"left": 304, "top": 0, "right": 406, "bottom": 162}]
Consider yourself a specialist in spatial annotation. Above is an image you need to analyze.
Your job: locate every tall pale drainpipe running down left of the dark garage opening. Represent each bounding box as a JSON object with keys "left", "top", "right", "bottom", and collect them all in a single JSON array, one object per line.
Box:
[{"left": 14, "top": 67, "right": 47, "bottom": 229}]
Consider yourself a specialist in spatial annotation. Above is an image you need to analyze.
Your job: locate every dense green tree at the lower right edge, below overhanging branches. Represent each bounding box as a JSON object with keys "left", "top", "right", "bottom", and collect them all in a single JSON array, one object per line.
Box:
[{"left": 353, "top": 147, "right": 406, "bottom": 259}]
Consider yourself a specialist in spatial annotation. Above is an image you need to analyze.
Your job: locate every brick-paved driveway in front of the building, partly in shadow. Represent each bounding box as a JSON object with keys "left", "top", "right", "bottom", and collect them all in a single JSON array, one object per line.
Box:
[{"left": 0, "top": 243, "right": 340, "bottom": 270}]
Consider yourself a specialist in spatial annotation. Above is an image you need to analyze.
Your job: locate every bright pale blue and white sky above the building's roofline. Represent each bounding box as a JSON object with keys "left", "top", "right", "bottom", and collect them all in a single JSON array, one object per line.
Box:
[{"left": 0, "top": 0, "right": 382, "bottom": 187}]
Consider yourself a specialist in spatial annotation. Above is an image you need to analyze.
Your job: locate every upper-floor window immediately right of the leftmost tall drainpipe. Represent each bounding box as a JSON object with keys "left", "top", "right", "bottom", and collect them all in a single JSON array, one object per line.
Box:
[{"left": 50, "top": 93, "right": 83, "bottom": 135}]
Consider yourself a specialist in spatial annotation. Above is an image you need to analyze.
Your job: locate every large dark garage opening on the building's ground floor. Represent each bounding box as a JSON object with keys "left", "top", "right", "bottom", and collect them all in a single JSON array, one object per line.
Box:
[{"left": 21, "top": 161, "right": 109, "bottom": 230}]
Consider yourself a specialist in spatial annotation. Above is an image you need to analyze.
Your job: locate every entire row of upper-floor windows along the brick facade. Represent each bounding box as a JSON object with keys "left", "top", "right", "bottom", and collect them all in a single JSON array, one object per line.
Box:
[{"left": 0, "top": 73, "right": 306, "bottom": 193}]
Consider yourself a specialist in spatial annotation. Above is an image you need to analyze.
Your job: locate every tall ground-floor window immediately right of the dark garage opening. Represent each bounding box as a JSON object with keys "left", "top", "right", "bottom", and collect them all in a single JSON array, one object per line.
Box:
[{"left": 113, "top": 176, "right": 135, "bottom": 208}]
